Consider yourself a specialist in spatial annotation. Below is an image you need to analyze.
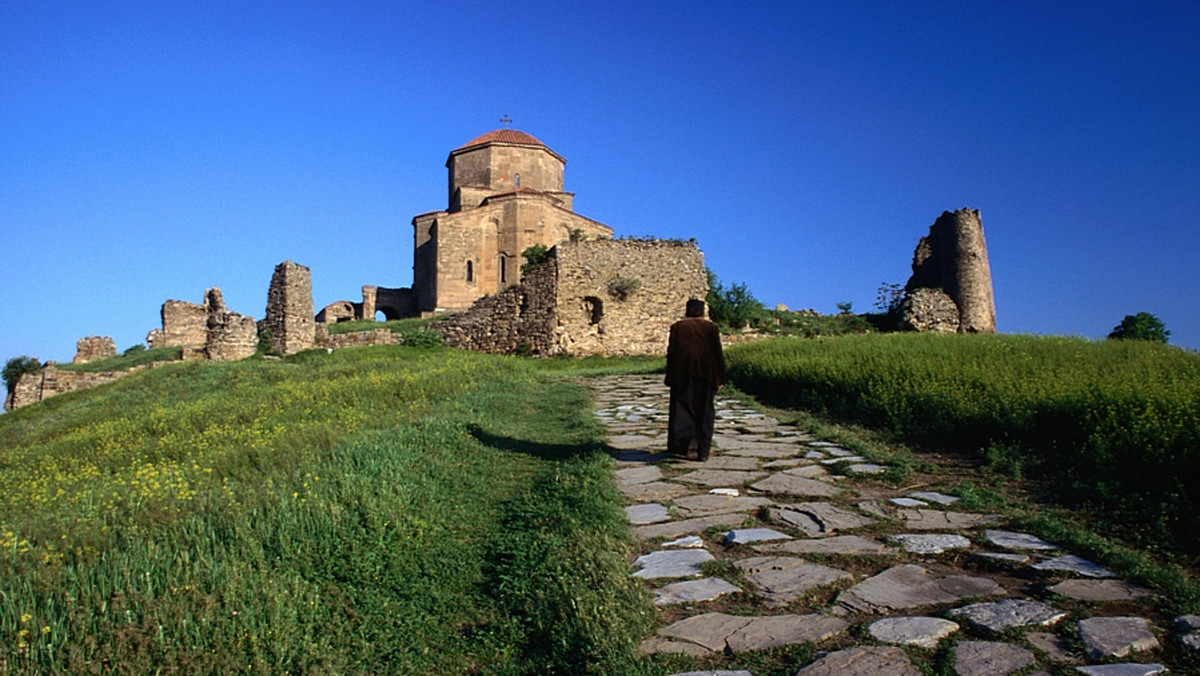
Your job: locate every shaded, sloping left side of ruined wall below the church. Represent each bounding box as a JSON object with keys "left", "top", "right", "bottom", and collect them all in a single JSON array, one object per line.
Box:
[{"left": 428, "top": 258, "right": 558, "bottom": 357}]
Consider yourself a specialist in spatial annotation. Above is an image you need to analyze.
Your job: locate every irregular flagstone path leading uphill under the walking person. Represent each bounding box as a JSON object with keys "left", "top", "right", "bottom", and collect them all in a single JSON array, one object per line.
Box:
[{"left": 592, "top": 376, "right": 1200, "bottom": 676}]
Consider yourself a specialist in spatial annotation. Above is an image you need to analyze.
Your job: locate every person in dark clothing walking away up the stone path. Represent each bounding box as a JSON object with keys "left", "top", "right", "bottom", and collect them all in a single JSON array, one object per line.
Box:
[{"left": 666, "top": 298, "right": 725, "bottom": 460}]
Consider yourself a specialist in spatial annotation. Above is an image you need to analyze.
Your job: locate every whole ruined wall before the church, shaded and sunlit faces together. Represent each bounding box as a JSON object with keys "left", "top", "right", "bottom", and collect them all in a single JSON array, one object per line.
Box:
[{"left": 430, "top": 240, "right": 708, "bottom": 357}]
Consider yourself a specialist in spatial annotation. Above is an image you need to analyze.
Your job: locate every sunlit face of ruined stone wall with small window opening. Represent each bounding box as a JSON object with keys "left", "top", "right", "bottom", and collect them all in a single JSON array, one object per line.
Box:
[{"left": 556, "top": 239, "right": 708, "bottom": 357}]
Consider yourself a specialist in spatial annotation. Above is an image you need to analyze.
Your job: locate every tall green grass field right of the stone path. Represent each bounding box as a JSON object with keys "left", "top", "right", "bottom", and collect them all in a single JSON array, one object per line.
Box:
[{"left": 730, "top": 334, "right": 1200, "bottom": 556}]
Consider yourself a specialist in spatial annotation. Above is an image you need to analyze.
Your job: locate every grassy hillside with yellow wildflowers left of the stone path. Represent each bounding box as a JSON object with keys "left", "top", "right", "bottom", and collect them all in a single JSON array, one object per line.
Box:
[{"left": 0, "top": 347, "right": 652, "bottom": 674}]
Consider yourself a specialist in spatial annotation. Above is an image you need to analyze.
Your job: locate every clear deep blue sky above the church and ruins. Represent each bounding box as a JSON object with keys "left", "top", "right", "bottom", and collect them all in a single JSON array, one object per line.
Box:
[{"left": 0, "top": 0, "right": 1200, "bottom": 361}]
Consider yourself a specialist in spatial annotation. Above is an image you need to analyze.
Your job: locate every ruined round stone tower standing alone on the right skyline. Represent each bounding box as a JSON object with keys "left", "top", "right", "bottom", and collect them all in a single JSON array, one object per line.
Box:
[{"left": 901, "top": 209, "right": 996, "bottom": 334}]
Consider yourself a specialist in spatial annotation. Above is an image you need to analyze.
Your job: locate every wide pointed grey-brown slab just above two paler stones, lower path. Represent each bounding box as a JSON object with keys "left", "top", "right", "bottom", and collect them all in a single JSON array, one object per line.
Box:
[{"left": 836, "top": 563, "right": 1004, "bottom": 614}]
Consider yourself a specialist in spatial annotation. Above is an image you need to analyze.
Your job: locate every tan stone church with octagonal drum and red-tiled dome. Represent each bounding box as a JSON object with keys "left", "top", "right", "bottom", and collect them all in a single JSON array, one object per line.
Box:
[{"left": 412, "top": 128, "right": 612, "bottom": 315}]
